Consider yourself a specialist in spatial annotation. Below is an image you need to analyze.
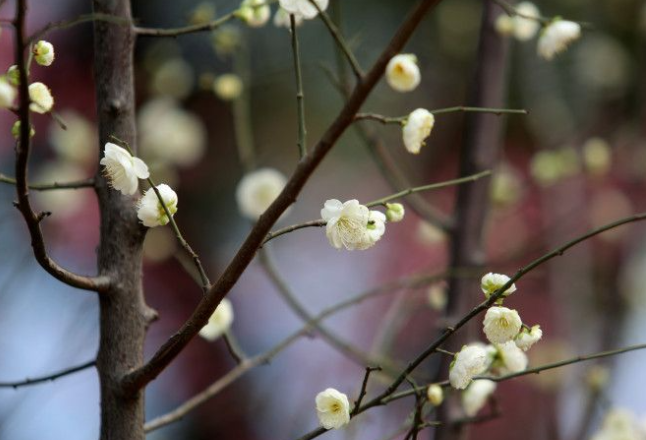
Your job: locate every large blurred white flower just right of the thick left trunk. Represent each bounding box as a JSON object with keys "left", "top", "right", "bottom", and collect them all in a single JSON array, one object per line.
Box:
[{"left": 137, "top": 98, "right": 206, "bottom": 166}]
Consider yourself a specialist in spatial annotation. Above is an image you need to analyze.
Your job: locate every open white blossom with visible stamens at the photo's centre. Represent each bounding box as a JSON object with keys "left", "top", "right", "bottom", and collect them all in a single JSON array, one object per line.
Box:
[{"left": 321, "top": 199, "right": 386, "bottom": 251}]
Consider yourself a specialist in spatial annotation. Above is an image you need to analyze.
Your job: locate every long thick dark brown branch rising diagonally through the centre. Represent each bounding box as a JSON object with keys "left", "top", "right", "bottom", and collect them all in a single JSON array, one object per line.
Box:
[{"left": 123, "top": 0, "right": 448, "bottom": 392}]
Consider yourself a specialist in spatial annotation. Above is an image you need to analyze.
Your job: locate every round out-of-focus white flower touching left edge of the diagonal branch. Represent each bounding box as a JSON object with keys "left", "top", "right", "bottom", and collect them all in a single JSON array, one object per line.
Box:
[{"left": 236, "top": 168, "right": 287, "bottom": 220}]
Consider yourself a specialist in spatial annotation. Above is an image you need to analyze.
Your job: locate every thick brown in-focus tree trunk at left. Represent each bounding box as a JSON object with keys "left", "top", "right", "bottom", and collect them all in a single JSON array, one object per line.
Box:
[{"left": 93, "top": 0, "right": 153, "bottom": 440}]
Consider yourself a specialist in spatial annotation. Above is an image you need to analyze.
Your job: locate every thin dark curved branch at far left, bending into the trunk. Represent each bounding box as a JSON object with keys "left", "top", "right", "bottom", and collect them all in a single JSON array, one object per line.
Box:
[{"left": 14, "top": 0, "right": 110, "bottom": 293}]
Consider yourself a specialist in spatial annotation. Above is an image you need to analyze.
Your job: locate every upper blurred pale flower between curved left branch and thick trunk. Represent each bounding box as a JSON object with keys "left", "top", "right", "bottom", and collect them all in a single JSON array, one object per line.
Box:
[{"left": 49, "top": 110, "right": 98, "bottom": 164}]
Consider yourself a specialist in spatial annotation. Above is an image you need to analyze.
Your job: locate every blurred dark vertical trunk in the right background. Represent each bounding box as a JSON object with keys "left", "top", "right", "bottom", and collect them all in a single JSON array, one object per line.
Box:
[{"left": 435, "top": 1, "right": 509, "bottom": 440}]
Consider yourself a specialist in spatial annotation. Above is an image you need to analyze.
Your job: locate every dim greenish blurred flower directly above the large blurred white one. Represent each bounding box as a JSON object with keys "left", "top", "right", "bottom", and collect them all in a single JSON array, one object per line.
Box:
[{"left": 150, "top": 57, "right": 195, "bottom": 99}]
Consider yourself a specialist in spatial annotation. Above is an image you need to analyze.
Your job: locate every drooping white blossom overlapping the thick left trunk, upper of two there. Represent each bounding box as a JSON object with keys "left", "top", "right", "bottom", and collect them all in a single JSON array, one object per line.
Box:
[{"left": 99, "top": 142, "right": 150, "bottom": 196}]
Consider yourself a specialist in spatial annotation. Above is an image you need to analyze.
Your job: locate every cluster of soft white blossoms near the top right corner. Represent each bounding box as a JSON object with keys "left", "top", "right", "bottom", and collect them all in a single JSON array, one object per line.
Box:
[{"left": 495, "top": 1, "right": 581, "bottom": 61}]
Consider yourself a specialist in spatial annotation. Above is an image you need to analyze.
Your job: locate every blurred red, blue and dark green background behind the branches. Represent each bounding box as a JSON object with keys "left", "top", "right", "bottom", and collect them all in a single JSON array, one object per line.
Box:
[{"left": 0, "top": 0, "right": 646, "bottom": 440}]
